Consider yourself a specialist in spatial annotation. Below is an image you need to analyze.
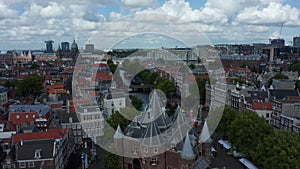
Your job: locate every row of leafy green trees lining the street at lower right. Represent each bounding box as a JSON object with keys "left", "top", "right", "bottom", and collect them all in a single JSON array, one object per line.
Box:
[{"left": 217, "top": 107, "right": 300, "bottom": 169}]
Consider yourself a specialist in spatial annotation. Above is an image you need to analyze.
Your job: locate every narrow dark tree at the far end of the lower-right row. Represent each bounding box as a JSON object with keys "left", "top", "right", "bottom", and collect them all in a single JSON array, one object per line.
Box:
[{"left": 217, "top": 106, "right": 238, "bottom": 137}]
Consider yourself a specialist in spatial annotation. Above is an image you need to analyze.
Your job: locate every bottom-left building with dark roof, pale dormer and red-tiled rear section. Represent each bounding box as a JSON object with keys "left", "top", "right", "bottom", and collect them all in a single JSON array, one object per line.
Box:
[{"left": 3, "top": 129, "right": 75, "bottom": 169}]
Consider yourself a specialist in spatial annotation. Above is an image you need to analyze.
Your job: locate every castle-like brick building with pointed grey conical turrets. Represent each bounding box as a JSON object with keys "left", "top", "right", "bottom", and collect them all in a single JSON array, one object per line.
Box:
[{"left": 114, "top": 91, "right": 212, "bottom": 169}]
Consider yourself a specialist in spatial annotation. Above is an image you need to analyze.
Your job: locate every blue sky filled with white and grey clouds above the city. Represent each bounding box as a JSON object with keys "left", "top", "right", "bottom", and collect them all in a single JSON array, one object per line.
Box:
[{"left": 0, "top": 0, "right": 300, "bottom": 50}]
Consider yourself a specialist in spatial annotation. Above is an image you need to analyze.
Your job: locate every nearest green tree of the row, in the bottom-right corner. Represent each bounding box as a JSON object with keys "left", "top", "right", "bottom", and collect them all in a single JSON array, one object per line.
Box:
[{"left": 252, "top": 130, "right": 300, "bottom": 169}]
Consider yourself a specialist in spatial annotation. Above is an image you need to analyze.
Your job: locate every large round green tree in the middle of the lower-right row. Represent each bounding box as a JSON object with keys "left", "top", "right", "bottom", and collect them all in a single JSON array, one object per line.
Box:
[{"left": 229, "top": 110, "right": 274, "bottom": 156}]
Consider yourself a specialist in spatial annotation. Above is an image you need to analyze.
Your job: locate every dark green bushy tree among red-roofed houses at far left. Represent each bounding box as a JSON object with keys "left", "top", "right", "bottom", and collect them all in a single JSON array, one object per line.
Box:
[{"left": 16, "top": 75, "right": 44, "bottom": 97}]
